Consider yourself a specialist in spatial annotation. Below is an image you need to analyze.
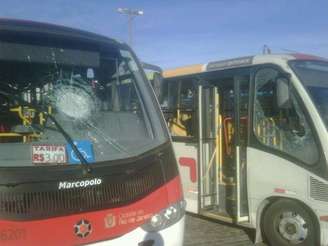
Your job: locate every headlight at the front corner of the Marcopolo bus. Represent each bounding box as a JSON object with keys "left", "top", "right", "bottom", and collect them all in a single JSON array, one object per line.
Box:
[{"left": 141, "top": 200, "right": 186, "bottom": 232}]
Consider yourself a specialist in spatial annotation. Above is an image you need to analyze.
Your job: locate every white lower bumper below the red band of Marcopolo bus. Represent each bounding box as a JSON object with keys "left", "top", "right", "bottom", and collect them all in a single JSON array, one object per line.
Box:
[{"left": 88, "top": 216, "right": 185, "bottom": 246}]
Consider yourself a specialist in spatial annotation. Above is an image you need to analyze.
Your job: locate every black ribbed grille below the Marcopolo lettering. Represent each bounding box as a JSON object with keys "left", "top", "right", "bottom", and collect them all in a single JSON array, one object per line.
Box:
[{"left": 0, "top": 162, "right": 163, "bottom": 220}]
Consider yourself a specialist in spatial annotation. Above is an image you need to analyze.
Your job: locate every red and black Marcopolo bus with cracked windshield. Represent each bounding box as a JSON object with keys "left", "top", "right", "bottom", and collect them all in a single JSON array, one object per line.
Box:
[{"left": 0, "top": 19, "right": 185, "bottom": 246}]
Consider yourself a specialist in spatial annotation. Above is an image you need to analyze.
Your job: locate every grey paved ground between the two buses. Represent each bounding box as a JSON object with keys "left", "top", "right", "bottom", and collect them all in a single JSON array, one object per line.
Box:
[{"left": 184, "top": 214, "right": 255, "bottom": 246}]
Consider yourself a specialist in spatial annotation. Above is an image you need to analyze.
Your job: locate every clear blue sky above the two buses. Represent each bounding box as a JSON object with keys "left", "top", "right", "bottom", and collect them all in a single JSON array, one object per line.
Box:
[{"left": 0, "top": 0, "right": 328, "bottom": 68}]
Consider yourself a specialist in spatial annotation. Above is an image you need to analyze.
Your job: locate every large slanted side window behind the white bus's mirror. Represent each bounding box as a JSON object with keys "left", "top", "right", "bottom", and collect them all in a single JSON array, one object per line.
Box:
[{"left": 254, "top": 68, "right": 319, "bottom": 165}]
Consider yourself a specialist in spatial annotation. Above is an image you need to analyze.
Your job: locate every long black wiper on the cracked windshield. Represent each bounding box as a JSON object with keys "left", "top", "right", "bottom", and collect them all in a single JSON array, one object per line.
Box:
[{"left": 0, "top": 90, "right": 92, "bottom": 175}]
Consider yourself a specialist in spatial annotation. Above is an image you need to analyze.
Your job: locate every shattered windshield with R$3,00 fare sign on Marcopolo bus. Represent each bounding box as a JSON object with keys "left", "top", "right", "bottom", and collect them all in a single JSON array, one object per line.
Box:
[{"left": 0, "top": 37, "right": 164, "bottom": 167}]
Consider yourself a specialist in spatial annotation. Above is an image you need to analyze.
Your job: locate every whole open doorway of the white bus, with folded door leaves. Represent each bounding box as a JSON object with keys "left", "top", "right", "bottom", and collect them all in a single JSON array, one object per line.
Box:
[{"left": 198, "top": 76, "right": 248, "bottom": 223}]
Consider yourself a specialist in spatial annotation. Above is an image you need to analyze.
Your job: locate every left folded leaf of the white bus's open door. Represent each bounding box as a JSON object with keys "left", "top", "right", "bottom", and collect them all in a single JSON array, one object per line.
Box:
[{"left": 198, "top": 85, "right": 221, "bottom": 213}]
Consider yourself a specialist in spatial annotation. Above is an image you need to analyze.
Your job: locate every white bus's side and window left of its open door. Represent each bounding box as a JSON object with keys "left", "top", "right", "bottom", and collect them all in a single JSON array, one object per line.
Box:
[{"left": 159, "top": 78, "right": 198, "bottom": 213}]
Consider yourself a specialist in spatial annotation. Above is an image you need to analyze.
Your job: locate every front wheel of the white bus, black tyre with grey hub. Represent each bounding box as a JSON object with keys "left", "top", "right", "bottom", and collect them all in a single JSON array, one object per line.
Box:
[{"left": 262, "top": 199, "right": 318, "bottom": 246}]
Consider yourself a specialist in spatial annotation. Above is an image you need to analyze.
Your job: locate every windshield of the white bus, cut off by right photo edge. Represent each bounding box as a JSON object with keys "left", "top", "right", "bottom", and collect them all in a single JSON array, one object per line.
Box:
[{"left": 291, "top": 61, "right": 328, "bottom": 129}]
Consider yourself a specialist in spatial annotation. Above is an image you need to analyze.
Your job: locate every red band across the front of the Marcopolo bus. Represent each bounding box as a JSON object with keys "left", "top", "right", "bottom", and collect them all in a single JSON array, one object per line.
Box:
[{"left": 0, "top": 176, "right": 182, "bottom": 246}]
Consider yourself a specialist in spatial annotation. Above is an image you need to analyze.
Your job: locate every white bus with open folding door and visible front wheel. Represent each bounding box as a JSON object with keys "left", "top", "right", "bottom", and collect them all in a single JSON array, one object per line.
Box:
[{"left": 159, "top": 54, "right": 328, "bottom": 246}]
